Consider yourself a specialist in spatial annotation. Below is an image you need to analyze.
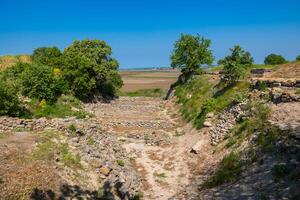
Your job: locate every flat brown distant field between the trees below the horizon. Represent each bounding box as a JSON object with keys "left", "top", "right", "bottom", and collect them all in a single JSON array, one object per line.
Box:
[{"left": 121, "top": 70, "right": 179, "bottom": 92}]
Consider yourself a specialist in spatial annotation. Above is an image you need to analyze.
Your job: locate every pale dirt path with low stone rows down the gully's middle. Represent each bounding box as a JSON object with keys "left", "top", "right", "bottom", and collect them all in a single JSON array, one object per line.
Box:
[{"left": 89, "top": 97, "right": 206, "bottom": 200}]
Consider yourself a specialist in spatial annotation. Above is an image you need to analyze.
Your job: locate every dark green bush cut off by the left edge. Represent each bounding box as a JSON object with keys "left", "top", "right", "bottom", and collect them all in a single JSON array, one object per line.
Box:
[{"left": 0, "top": 80, "right": 21, "bottom": 117}]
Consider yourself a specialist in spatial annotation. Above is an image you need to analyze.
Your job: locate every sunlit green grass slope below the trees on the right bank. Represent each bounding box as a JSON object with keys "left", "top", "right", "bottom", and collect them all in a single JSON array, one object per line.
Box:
[{"left": 175, "top": 76, "right": 250, "bottom": 128}]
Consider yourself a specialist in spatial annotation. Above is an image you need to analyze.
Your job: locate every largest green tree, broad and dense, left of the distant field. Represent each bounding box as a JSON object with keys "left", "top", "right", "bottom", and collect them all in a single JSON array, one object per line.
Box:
[{"left": 62, "top": 40, "right": 123, "bottom": 100}]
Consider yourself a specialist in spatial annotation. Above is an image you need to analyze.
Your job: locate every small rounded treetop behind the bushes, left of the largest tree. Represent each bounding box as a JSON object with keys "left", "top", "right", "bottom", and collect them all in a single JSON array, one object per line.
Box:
[{"left": 31, "top": 47, "right": 62, "bottom": 67}]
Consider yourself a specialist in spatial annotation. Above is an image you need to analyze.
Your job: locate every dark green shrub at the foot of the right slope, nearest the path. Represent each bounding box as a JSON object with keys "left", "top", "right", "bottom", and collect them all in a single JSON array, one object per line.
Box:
[{"left": 204, "top": 152, "right": 242, "bottom": 188}]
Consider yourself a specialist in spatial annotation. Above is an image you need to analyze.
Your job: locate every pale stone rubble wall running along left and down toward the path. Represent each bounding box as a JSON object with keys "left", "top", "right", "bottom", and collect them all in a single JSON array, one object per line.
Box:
[{"left": 0, "top": 117, "right": 141, "bottom": 199}]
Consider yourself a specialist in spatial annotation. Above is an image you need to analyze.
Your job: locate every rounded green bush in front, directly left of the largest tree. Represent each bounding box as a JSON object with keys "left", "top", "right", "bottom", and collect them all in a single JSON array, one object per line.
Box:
[{"left": 20, "top": 64, "right": 67, "bottom": 103}]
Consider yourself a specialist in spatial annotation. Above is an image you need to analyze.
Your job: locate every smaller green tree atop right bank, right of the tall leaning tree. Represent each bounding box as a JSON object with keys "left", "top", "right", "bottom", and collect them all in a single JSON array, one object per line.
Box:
[{"left": 219, "top": 45, "right": 254, "bottom": 85}]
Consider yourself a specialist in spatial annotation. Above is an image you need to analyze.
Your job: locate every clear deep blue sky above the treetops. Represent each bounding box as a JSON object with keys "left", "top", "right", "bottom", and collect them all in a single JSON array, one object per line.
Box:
[{"left": 0, "top": 0, "right": 300, "bottom": 68}]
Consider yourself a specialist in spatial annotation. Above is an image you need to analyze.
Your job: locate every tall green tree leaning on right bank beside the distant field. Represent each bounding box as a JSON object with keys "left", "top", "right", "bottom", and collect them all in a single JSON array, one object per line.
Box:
[{"left": 171, "top": 34, "right": 214, "bottom": 82}]
